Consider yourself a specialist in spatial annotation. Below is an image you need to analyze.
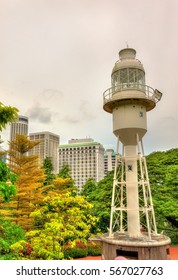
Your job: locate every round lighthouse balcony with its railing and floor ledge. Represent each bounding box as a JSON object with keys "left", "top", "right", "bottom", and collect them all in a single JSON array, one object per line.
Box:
[{"left": 103, "top": 83, "right": 162, "bottom": 113}]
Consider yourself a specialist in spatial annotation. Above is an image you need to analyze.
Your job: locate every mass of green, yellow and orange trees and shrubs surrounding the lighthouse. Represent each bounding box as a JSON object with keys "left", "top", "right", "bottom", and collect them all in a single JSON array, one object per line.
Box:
[{"left": 0, "top": 101, "right": 178, "bottom": 260}]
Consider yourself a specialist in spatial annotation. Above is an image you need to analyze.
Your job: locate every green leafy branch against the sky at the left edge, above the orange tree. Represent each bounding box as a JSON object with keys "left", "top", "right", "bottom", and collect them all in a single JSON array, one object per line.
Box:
[{"left": 0, "top": 102, "right": 18, "bottom": 131}]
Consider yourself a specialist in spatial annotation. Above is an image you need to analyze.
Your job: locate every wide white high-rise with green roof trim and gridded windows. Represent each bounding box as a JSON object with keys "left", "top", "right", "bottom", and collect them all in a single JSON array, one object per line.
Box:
[{"left": 59, "top": 138, "right": 104, "bottom": 192}]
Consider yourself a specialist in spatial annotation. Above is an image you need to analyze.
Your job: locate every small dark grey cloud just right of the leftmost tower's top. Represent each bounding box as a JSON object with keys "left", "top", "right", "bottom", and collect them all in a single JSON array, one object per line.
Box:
[{"left": 26, "top": 100, "right": 52, "bottom": 123}]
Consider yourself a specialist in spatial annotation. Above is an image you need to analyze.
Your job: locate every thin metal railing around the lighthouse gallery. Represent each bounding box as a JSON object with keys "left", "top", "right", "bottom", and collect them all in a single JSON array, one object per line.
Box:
[{"left": 103, "top": 83, "right": 157, "bottom": 104}]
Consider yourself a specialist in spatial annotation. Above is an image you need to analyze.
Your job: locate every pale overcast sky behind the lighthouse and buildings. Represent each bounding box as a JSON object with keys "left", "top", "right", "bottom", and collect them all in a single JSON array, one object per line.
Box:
[{"left": 0, "top": 0, "right": 178, "bottom": 154}]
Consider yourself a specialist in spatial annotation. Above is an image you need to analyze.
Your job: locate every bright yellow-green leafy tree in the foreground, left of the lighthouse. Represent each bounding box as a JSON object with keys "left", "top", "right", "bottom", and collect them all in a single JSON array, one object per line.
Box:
[{"left": 12, "top": 192, "right": 96, "bottom": 260}]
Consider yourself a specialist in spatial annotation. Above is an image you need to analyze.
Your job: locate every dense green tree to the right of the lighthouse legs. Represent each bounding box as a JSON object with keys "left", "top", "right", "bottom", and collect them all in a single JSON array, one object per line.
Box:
[{"left": 147, "top": 149, "right": 178, "bottom": 243}]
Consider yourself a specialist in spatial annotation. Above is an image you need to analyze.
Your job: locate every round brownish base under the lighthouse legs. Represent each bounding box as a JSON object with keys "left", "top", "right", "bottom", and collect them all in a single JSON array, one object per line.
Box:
[{"left": 101, "top": 232, "right": 171, "bottom": 260}]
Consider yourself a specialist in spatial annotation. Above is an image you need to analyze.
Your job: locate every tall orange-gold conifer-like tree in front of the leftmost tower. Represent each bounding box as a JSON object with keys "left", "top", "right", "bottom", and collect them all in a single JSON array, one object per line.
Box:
[{"left": 4, "top": 135, "right": 45, "bottom": 230}]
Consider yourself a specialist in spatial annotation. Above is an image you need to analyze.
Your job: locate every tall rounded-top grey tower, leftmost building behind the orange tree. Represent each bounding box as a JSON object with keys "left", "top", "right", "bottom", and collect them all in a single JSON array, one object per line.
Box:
[{"left": 10, "top": 115, "right": 28, "bottom": 141}]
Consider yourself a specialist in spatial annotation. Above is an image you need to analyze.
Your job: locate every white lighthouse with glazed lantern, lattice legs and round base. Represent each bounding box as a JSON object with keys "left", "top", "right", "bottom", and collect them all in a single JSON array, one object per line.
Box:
[{"left": 102, "top": 48, "right": 170, "bottom": 259}]
